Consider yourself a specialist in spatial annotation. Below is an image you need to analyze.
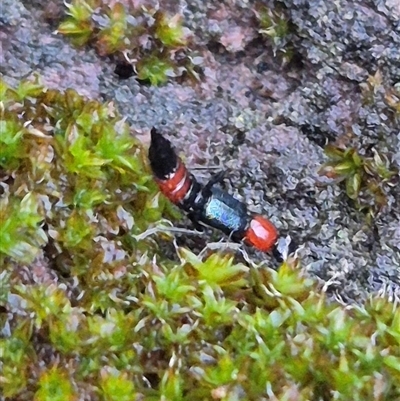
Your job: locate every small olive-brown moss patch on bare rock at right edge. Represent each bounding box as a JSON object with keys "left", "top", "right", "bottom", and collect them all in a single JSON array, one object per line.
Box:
[{"left": 320, "top": 70, "right": 399, "bottom": 219}]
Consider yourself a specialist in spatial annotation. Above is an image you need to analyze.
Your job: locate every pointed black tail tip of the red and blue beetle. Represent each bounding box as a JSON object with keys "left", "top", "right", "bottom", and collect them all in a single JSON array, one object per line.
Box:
[{"left": 149, "top": 127, "right": 178, "bottom": 179}]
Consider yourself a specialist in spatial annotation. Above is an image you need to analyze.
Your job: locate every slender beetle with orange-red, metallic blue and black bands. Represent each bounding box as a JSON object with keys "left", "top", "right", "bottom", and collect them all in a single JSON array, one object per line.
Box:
[{"left": 149, "top": 128, "right": 292, "bottom": 259}]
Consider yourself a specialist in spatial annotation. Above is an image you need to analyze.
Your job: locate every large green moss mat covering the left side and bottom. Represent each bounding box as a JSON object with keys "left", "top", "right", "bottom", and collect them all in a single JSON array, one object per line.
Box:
[{"left": 0, "top": 76, "right": 400, "bottom": 401}]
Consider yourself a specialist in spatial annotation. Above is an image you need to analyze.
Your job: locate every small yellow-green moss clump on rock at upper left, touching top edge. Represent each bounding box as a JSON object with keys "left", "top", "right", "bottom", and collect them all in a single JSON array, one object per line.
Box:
[{"left": 58, "top": 0, "right": 197, "bottom": 85}]
